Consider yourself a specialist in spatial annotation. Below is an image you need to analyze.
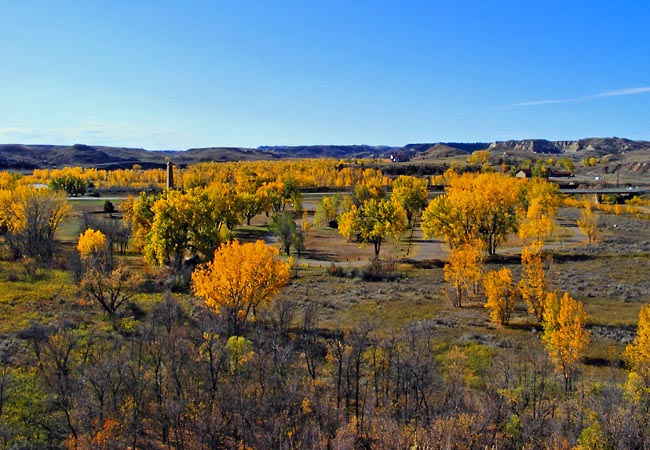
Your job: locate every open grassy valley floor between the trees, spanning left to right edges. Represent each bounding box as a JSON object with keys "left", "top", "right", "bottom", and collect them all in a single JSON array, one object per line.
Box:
[{"left": 0, "top": 194, "right": 650, "bottom": 378}]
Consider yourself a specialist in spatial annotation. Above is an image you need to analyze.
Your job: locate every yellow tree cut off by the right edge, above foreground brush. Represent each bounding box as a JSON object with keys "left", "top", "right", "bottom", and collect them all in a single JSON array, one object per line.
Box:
[{"left": 623, "top": 304, "right": 650, "bottom": 399}]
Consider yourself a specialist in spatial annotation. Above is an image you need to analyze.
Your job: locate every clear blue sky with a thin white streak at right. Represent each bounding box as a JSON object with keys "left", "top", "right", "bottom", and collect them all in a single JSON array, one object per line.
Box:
[{"left": 0, "top": 0, "right": 650, "bottom": 150}]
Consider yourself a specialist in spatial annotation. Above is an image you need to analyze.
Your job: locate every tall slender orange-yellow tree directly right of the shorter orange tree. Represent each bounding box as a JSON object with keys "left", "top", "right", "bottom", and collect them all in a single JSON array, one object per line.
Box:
[{"left": 518, "top": 241, "right": 547, "bottom": 321}]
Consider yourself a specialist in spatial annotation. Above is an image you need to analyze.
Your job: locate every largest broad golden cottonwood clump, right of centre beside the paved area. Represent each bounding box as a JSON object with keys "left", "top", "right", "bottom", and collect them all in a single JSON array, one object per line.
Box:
[{"left": 421, "top": 173, "right": 521, "bottom": 255}]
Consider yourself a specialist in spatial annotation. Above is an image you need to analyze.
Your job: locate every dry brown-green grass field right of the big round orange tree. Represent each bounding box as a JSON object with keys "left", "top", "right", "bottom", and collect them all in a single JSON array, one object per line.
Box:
[{"left": 268, "top": 203, "right": 650, "bottom": 372}]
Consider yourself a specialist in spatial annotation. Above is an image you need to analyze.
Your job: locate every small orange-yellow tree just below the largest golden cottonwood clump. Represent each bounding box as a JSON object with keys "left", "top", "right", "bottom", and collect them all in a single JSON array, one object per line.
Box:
[{"left": 444, "top": 239, "right": 485, "bottom": 308}]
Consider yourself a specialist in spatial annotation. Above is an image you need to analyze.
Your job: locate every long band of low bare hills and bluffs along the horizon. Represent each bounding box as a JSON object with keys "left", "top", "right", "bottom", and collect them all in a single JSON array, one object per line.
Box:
[{"left": 0, "top": 138, "right": 650, "bottom": 175}]
